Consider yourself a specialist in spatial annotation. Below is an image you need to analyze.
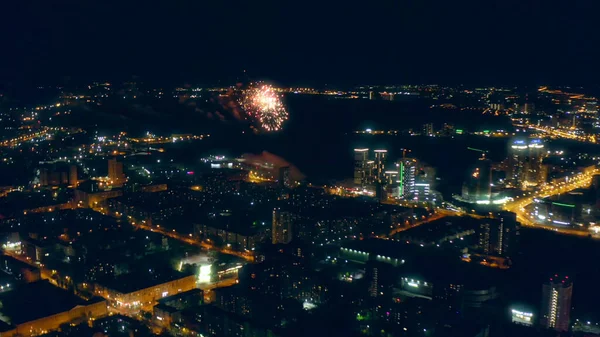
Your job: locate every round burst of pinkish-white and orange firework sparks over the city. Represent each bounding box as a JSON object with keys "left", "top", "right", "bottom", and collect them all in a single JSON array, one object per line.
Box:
[{"left": 240, "top": 83, "right": 288, "bottom": 131}]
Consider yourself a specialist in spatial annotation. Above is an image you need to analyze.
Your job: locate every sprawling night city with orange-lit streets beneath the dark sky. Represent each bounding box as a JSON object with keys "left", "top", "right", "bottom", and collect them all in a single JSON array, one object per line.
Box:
[{"left": 0, "top": 77, "right": 600, "bottom": 337}]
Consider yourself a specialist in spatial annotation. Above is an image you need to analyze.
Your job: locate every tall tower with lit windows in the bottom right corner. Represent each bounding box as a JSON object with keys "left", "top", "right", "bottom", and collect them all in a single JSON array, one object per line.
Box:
[{"left": 540, "top": 274, "right": 573, "bottom": 331}]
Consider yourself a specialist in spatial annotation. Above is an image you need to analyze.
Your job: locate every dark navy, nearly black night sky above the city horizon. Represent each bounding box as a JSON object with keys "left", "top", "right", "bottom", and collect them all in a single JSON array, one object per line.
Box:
[{"left": 0, "top": 0, "right": 600, "bottom": 84}]
